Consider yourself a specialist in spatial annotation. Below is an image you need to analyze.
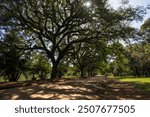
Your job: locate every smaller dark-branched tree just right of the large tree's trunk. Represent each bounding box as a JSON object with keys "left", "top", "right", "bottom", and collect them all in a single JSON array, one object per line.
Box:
[{"left": 68, "top": 40, "right": 107, "bottom": 77}]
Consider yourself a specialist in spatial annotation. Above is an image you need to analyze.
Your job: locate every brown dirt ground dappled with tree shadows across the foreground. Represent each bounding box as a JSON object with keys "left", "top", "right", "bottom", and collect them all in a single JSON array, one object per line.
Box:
[{"left": 0, "top": 77, "right": 150, "bottom": 100}]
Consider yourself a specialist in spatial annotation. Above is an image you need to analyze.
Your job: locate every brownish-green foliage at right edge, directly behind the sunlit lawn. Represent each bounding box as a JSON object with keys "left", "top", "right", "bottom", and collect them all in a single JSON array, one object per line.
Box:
[{"left": 128, "top": 43, "right": 150, "bottom": 76}]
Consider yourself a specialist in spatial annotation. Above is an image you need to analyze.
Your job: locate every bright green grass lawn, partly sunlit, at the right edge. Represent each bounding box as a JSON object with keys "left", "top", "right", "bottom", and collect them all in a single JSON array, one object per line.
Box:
[{"left": 115, "top": 77, "right": 150, "bottom": 91}]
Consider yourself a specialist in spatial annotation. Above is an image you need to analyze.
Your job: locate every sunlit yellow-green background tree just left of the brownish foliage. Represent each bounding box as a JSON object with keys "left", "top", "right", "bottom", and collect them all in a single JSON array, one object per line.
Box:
[{"left": 108, "top": 42, "right": 129, "bottom": 76}]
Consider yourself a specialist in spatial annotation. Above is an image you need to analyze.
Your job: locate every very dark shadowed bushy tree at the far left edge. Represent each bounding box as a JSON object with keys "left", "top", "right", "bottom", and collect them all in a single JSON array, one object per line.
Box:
[{"left": 0, "top": 31, "right": 26, "bottom": 81}]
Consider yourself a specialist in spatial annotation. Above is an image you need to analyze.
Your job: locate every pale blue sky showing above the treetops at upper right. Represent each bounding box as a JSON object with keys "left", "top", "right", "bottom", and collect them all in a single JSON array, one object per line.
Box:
[{"left": 110, "top": 0, "right": 150, "bottom": 28}]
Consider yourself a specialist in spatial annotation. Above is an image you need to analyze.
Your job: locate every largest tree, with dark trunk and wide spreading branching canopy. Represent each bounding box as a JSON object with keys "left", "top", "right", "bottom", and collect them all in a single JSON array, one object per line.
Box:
[{"left": 0, "top": 0, "right": 143, "bottom": 78}]
